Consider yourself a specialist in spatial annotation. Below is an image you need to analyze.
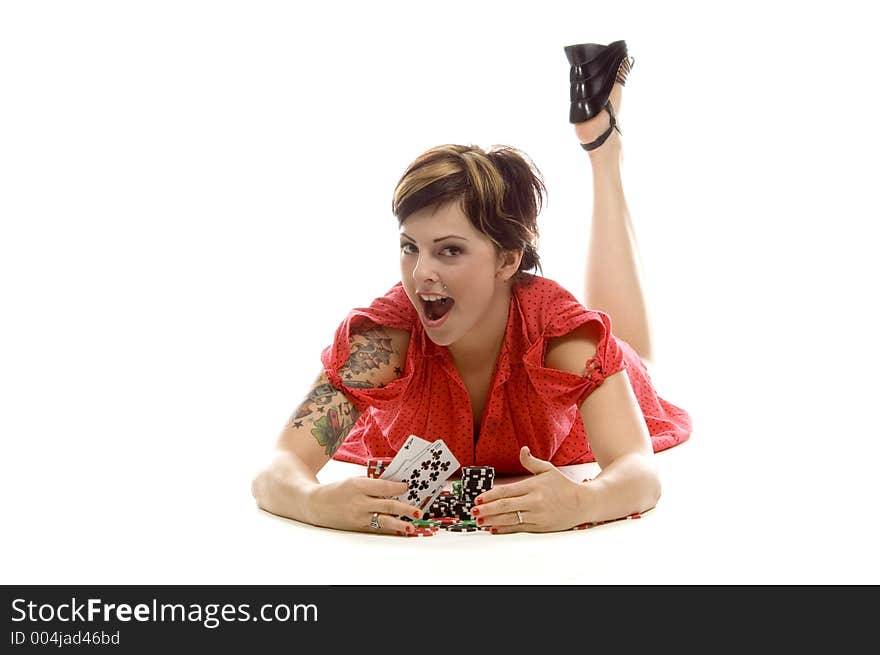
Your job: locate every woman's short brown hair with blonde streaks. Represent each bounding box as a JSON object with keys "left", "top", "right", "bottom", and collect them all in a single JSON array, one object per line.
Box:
[{"left": 391, "top": 144, "right": 547, "bottom": 277}]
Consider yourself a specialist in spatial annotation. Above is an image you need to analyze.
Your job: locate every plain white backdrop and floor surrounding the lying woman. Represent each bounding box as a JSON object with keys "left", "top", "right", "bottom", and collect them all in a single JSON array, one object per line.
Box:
[{"left": 0, "top": 1, "right": 880, "bottom": 584}]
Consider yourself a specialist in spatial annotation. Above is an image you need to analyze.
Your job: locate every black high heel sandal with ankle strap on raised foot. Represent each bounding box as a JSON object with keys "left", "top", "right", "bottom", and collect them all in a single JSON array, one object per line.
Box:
[{"left": 564, "top": 41, "right": 635, "bottom": 150}]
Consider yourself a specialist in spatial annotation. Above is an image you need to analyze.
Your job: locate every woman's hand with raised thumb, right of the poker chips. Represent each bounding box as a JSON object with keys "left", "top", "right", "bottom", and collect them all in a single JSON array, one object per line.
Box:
[{"left": 471, "top": 446, "right": 586, "bottom": 534}]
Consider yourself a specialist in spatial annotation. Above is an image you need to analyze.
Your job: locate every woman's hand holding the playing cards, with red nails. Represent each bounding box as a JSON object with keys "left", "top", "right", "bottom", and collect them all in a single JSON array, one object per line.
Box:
[{"left": 309, "top": 477, "right": 422, "bottom": 535}]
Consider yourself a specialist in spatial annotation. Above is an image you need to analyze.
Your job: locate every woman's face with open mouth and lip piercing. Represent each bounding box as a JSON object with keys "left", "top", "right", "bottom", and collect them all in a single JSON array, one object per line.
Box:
[{"left": 400, "top": 202, "right": 502, "bottom": 346}]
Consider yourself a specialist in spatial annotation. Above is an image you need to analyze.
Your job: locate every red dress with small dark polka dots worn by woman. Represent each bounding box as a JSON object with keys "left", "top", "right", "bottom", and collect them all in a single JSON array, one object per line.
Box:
[{"left": 321, "top": 275, "right": 692, "bottom": 474}]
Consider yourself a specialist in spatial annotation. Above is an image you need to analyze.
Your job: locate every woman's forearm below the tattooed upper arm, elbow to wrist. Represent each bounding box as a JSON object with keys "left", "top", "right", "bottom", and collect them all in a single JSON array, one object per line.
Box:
[{"left": 251, "top": 451, "right": 319, "bottom": 523}]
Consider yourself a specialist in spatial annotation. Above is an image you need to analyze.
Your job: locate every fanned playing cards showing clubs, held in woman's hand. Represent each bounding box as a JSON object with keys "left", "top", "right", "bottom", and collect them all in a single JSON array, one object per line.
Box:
[{"left": 380, "top": 435, "right": 459, "bottom": 512}]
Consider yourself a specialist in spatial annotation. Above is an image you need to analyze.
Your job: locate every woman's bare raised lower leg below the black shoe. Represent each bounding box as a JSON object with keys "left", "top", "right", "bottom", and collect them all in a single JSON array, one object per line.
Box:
[{"left": 575, "top": 84, "right": 653, "bottom": 364}]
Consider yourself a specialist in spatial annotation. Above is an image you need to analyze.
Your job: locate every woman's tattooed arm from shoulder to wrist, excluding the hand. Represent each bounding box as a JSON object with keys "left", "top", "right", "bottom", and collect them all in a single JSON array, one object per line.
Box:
[{"left": 251, "top": 325, "right": 409, "bottom": 525}]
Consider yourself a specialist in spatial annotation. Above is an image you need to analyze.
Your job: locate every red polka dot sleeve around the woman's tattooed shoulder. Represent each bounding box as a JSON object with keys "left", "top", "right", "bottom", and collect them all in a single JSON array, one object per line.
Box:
[{"left": 321, "top": 282, "right": 416, "bottom": 413}]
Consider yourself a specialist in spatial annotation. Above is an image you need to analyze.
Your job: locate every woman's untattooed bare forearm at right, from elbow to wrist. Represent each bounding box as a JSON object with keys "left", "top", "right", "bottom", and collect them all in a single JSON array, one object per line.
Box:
[{"left": 583, "top": 453, "right": 660, "bottom": 523}]
